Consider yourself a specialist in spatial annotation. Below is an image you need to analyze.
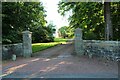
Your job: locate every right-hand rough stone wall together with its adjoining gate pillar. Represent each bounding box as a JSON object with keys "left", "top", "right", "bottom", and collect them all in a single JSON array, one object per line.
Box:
[{"left": 75, "top": 28, "right": 120, "bottom": 60}]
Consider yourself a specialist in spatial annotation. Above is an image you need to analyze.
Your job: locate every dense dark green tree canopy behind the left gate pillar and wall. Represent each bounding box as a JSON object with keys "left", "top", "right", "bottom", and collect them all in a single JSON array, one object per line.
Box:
[{"left": 2, "top": 2, "right": 53, "bottom": 43}]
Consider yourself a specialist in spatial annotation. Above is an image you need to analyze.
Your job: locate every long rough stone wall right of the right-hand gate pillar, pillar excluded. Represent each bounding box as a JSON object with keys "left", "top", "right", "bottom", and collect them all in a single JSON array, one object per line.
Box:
[{"left": 83, "top": 40, "right": 120, "bottom": 60}]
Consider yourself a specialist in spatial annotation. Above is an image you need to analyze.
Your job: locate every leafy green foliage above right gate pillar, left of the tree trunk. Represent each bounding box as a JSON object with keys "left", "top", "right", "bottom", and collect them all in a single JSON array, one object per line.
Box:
[{"left": 58, "top": 2, "right": 104, "bottom": 39}]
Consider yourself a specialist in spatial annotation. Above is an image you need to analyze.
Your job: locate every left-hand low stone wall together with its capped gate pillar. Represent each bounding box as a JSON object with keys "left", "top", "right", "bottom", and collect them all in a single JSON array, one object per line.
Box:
[{"left": 2, "top": 31, "right": 32, "bottom": 60}]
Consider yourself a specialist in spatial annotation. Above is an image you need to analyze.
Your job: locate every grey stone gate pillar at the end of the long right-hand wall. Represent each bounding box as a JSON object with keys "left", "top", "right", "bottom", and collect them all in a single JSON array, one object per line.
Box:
[{"left": 75, "top": 28, "right": 84, "bottom": 56}]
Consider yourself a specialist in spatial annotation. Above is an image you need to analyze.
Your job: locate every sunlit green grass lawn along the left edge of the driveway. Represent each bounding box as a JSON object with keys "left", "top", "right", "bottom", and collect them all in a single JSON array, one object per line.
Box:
[{"left": 32, "top": 38, "right": 67, "bottom": 53}]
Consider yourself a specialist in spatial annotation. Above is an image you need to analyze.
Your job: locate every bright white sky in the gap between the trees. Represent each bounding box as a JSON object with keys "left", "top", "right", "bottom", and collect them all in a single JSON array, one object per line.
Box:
[{"left": 40, "top": 0, "right": 69, "bottom": 36}]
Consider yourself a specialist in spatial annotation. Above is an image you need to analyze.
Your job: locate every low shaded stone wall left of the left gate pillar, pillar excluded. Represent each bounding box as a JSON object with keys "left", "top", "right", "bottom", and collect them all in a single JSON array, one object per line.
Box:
[{"left": 2, "top": 43, "right": 23, "bottom": 59}]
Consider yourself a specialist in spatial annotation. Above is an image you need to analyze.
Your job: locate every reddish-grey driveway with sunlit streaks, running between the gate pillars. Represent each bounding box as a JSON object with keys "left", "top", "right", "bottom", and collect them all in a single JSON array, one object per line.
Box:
[{"left": 3, "top": 43, "right": 118, "bottom": 78}]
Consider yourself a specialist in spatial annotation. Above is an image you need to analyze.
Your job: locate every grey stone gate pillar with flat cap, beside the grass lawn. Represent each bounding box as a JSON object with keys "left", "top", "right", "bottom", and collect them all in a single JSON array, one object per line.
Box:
[{"left": 22, "top": 31, "right": 32, "bottom": 57}]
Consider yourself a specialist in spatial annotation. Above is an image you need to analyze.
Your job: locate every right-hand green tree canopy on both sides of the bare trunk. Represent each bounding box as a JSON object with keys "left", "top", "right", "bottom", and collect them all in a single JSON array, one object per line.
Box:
[{"left": 58, "top": 2, "right": 120, "bottom": 40}]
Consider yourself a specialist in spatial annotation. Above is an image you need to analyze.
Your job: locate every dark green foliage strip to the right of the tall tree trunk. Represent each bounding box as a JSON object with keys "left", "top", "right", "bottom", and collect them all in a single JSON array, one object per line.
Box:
[{"left": 111, "top": 2, "right": 120, "bottom": 40}]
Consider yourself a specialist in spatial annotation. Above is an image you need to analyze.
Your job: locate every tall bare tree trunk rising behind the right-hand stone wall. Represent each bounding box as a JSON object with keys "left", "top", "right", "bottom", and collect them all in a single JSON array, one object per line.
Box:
[{"left": 104, "top": 2, "right": 113, "bottom": 40}]
